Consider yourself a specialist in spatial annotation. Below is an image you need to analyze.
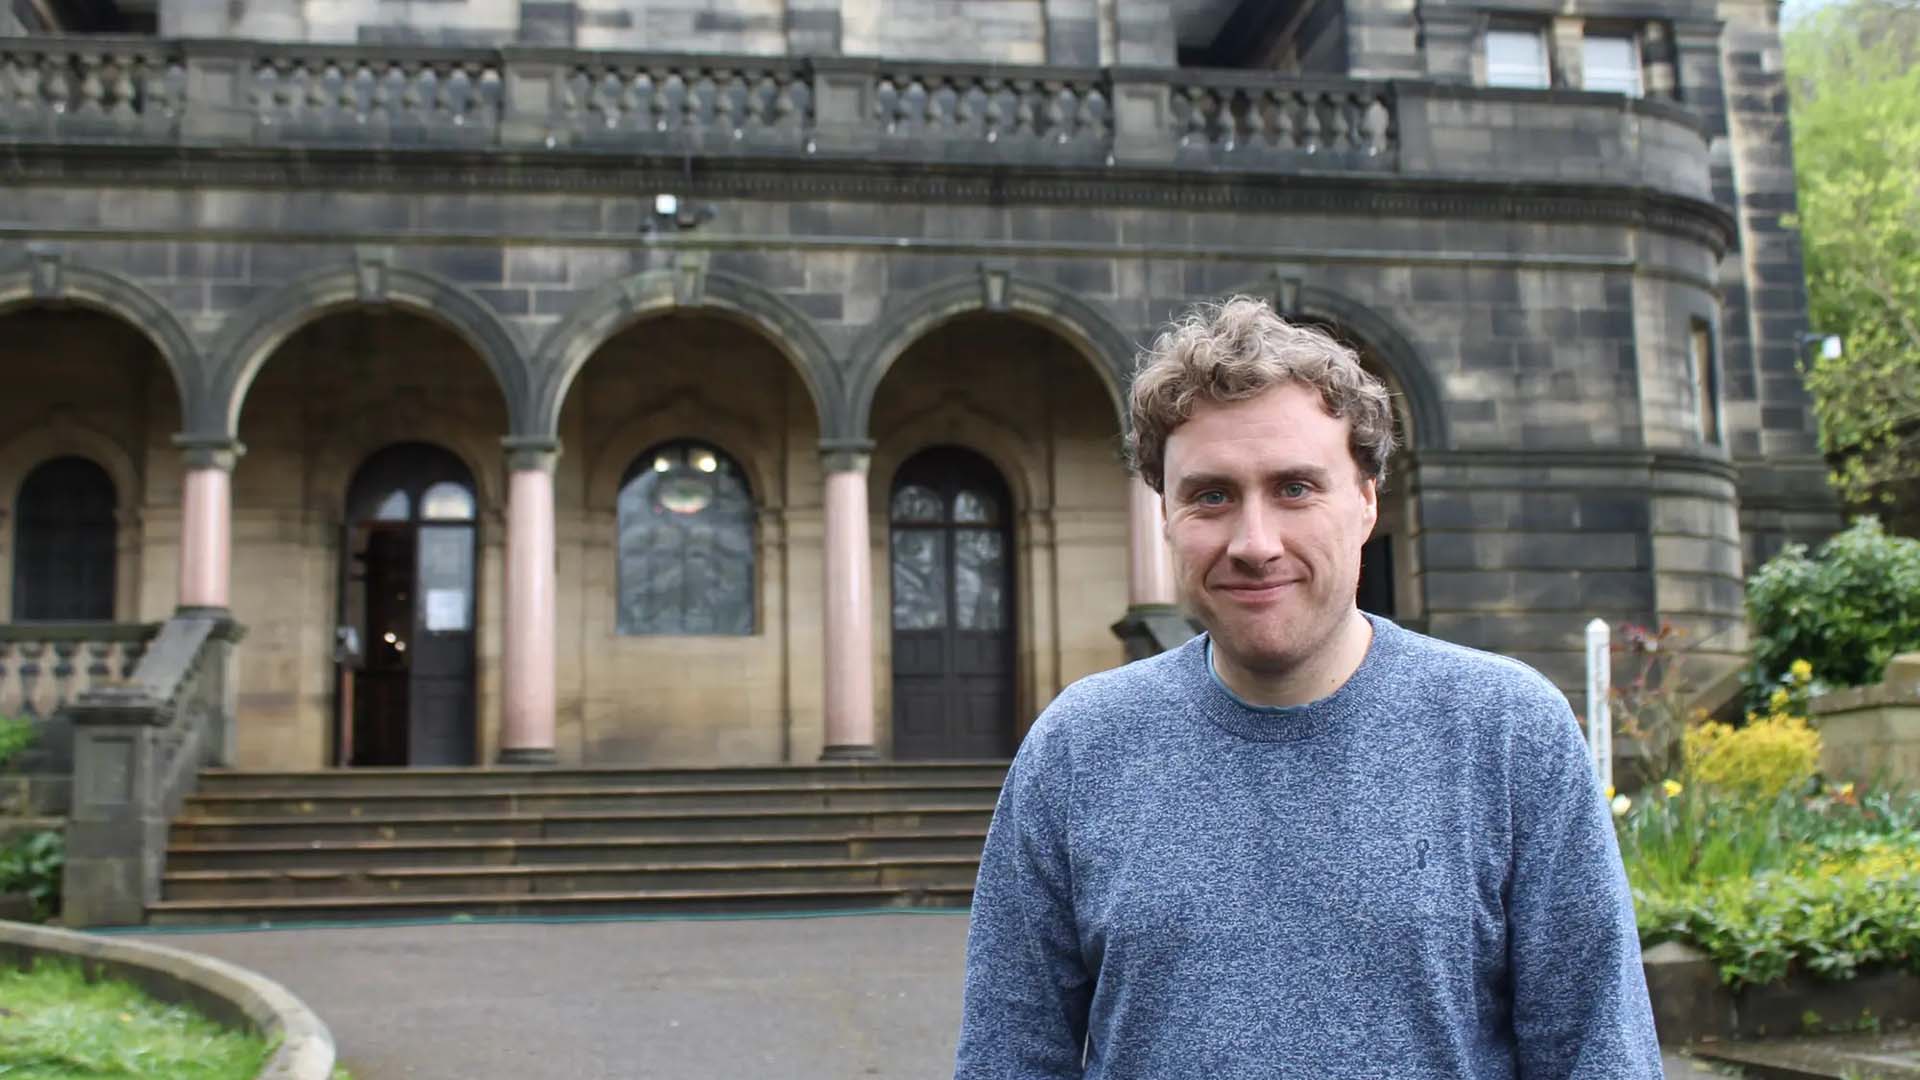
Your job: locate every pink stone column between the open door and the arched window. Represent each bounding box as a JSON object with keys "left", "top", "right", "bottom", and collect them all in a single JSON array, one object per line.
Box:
[{"left": 499, "top": 438, "right": 559, "bottom": 765}]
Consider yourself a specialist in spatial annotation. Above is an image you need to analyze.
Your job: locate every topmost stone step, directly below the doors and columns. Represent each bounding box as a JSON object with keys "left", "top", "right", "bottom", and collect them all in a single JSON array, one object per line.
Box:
[{"left": 187, "top": 761, "right": 1008, "bottom": 796}]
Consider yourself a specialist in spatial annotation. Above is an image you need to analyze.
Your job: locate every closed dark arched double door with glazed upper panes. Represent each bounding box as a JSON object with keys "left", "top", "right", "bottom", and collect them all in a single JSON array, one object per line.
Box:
[{"left": 889, "top": 446, "right": 1014, "bottom": 759}]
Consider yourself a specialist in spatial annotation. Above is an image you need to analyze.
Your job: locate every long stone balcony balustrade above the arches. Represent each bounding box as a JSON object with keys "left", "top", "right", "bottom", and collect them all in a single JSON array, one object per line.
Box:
[{"left": 0, "top": 37, "right": 1713, "bottom": 200}]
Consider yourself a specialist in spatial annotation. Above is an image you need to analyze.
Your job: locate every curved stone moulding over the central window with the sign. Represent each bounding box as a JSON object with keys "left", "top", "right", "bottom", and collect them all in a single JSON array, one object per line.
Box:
[{"left": 584, "top": 390, "right": 785, "bottom": 513}]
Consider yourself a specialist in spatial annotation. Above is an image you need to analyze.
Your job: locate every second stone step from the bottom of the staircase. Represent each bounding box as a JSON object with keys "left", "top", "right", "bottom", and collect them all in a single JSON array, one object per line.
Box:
[{"left": 161, "top": 855, "right": 979, "bottom": 899}]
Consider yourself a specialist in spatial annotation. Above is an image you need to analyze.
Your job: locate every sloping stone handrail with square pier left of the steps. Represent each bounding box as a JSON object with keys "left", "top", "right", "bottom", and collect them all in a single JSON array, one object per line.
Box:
[{"left": 63, "top": 609, "right": 240, "bottom": 926}]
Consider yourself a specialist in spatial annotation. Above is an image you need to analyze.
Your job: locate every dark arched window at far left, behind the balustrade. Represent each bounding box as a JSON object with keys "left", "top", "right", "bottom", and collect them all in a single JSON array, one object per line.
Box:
[{"left": 13, "top": 457, "right": 117, "bottom": 623}]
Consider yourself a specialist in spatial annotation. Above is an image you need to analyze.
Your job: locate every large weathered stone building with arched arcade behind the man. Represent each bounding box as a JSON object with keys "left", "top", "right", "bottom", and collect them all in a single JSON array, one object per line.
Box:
[{"left": 0, "top": 0, "right": 1834, "bottom": 769}]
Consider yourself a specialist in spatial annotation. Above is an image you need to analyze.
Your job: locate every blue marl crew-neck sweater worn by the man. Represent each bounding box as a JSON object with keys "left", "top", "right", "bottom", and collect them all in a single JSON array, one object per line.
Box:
[{"left": 958, "top": 619, "right": 1661, "bottom": 1080}]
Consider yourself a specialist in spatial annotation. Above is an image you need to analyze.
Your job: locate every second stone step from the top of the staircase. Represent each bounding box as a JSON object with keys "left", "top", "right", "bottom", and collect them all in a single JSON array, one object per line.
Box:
[{"left": 182, "top": 778, "right": 1000, "bottom": 819}]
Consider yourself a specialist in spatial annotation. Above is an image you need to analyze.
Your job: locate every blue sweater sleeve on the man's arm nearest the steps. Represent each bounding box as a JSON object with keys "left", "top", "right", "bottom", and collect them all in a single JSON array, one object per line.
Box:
[{"left": 954, "top": 703, "right": 1092, "bottom": 1080}]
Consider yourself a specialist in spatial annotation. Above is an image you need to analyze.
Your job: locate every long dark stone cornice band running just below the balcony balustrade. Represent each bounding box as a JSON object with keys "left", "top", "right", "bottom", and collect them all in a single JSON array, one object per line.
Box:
[{"left": 0, "top": 144, "right": 1736, "bottom": 254}]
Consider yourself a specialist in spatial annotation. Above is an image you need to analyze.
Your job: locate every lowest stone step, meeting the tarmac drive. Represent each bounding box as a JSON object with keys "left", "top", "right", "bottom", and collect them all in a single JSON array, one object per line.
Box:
[{"left": 148, "top": 886, "right": 973, "bottom": 926}]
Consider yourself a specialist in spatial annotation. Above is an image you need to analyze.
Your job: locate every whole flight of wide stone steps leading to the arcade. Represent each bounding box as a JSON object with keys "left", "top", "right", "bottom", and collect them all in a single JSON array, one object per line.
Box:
[{"left": 148, "top": 761, "right": 1006, "bottom": 924}]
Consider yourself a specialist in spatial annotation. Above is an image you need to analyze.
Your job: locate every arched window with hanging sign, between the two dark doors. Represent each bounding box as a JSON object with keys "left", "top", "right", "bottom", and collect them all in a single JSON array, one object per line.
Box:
[{"left": 616, "top": 440, "right": 755, "bottom": 634}]
